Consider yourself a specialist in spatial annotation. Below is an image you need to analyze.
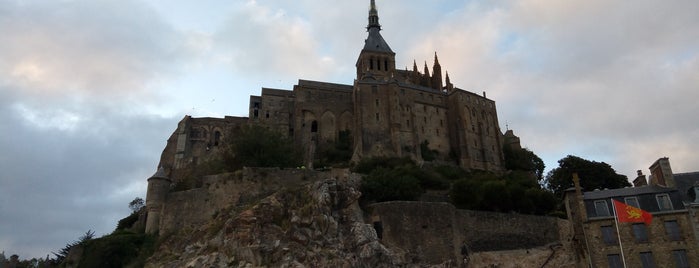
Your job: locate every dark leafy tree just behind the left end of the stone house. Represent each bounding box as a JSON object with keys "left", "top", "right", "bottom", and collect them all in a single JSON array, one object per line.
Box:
[{"left": 545, "top": 155, "right": 631, "bottom": 197}]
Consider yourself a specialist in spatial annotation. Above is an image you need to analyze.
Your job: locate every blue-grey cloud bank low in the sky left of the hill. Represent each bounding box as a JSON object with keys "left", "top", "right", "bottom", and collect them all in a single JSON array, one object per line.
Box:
[{"left": 0, "top": 89, "right": 176, "bottom": 258}]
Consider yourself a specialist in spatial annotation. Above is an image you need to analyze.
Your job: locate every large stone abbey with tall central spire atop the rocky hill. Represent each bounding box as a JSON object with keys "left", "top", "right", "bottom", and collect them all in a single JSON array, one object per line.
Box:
[{"left": 161, "top": 0, "right": 519, "bottom": 178}]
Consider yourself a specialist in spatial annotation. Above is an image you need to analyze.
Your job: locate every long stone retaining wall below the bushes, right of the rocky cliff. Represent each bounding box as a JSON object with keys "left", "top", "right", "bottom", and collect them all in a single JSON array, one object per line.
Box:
[{"left": 370, "top": 201, "right": 573, "bottom": 264}]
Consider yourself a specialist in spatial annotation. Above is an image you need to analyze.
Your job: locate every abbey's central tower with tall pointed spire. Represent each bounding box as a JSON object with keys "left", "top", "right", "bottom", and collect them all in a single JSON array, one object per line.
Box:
[{"left": 356, "top": 0, "right": 396, "bottom": 79}]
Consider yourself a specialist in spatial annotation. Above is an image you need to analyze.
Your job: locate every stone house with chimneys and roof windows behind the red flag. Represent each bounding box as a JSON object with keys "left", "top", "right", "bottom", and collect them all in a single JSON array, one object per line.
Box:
[{"left": 565, "top": 158, "right": 699, "bottom": 268}]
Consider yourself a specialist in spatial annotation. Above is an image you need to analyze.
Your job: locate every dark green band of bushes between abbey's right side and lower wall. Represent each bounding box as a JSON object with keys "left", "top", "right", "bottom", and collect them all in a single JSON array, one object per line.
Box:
[{"left": 353, "top": 146, "right": 562, "bottom": 215}]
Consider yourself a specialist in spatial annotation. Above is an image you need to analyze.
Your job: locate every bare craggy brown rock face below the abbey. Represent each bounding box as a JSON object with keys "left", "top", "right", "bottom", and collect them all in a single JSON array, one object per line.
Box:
[{"left": 146, "top": 173, "right": 405, "bottom": 267}]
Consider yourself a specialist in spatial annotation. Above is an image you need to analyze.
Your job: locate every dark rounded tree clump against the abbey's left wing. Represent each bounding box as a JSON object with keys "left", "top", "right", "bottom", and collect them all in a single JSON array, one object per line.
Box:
[{"left": 223, "top": 125, "right": 300, "bottom": 169}]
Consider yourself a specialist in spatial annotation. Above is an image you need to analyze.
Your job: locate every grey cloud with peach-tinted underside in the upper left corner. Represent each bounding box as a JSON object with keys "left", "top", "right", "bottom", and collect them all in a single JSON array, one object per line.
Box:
[{"left": 0, "top": 1, "right": 181, "bottom": 96}]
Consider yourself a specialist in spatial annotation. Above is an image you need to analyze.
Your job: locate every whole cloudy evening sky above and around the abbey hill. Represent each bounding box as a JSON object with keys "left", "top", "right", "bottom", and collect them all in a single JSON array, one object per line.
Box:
[{"left": 0, "top": 0, "right": 699, "bottom": 259}]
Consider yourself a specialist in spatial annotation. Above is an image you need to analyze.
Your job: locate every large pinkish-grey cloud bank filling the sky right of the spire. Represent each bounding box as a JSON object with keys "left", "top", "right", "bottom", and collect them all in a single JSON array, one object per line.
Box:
[{"left": 389, "top": 0, "right": 699, "bottom": 176}]
